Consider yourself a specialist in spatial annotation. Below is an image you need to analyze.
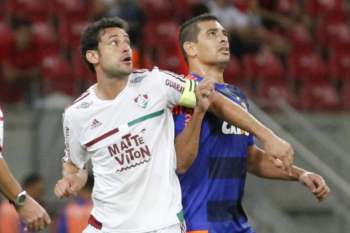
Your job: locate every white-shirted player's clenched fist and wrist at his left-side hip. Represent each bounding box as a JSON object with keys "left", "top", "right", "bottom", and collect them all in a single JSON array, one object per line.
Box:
[{"left": 54, "top": 162, "right": 88, "bottom": 198}]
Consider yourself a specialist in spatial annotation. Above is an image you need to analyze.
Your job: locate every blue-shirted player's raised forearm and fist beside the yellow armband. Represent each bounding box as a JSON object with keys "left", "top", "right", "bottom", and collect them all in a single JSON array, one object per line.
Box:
[{"left": 175, "top": 80, "right": 214, "bottom": 173}]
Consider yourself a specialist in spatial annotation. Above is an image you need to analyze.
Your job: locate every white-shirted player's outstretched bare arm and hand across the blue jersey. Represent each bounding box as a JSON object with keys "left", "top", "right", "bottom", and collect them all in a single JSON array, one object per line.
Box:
[{"left": 210, "top": 92, "right": 294, "bottom": 172}]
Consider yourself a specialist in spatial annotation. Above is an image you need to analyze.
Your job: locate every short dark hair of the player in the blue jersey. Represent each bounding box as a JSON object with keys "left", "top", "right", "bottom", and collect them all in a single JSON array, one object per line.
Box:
[{"left": 179, "top": 13, "right": 220, "bottom": 62}]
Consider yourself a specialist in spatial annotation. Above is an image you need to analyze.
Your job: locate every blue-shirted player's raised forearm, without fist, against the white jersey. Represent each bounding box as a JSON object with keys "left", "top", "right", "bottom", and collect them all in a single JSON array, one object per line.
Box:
[{"left": 175, "top": 108, "right": 205, "bottom": 173}]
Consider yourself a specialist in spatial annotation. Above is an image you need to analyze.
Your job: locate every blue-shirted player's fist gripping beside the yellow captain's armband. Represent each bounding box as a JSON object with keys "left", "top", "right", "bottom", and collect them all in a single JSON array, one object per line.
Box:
[{"left": 195, "top": 79, "right": 214, "bottom": 112}]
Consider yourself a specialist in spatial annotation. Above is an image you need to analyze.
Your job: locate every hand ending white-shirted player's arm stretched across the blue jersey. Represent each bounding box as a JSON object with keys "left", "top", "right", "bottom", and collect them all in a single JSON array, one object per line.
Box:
[{"left": 264, "top": 134, "right": 294, "bottom": 174}]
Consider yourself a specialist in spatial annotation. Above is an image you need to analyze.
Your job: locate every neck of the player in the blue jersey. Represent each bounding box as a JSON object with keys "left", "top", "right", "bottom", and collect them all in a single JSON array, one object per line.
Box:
[{"left": 189, "top": 63, "right": 225, "bottom": 83}]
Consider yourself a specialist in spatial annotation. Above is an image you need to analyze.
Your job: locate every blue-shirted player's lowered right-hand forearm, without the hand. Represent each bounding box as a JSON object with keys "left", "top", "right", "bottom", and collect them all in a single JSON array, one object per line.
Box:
[{"left": 247, "top": 146, "right": 305, "bottom": 181}]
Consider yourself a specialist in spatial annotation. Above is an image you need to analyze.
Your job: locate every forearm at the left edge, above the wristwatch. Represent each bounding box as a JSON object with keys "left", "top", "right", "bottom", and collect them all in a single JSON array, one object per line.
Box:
[{"left": 0, "top": 159, "right": 22, "bottom": 200}]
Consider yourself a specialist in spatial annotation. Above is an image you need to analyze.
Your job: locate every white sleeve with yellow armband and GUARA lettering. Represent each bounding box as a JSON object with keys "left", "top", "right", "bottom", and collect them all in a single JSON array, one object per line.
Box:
[{"left": 159, "top": 71, "right": 198, "bottom": 108}]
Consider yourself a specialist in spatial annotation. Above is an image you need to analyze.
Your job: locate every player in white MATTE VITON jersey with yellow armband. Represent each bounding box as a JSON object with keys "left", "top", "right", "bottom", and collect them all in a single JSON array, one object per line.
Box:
[{"left": 55, "top": 17, "right": 213, "bottom": 233}]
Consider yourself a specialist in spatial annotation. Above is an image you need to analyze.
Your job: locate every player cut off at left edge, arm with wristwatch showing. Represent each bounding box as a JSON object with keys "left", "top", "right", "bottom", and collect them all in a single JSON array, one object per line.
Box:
[{"left": 0, "top": 108, "right": 51, "bottom": 231}]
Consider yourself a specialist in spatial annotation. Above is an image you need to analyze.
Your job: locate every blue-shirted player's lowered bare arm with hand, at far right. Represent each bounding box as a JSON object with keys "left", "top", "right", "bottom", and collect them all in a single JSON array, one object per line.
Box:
[{"left": 247, "top": 146, "right": 330, "bottom": 201}]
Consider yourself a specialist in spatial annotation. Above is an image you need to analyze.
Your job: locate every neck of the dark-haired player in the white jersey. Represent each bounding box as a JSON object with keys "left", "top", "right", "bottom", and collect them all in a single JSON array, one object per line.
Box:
[{"left": 95, "top": 73, "right": 128, "bottom": 100}]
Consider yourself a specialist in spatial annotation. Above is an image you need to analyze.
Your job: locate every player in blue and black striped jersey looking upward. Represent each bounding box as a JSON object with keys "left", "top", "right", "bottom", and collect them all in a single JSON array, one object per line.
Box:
[{"left": 174, "top": 14, "right": 329, "bottom": 233}]
